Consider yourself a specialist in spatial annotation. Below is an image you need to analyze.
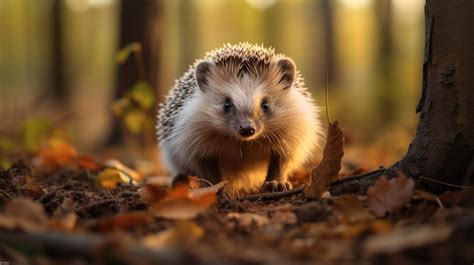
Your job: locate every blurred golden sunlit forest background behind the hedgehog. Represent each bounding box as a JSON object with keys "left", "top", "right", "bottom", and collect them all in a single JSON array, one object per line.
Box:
[{"left": 0, "top": 0, "right": 424, "bottom": 167}]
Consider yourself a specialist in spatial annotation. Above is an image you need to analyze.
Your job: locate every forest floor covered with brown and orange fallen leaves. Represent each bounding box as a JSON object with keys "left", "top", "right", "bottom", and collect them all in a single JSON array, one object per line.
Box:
[{"left": 0, "top": 139, "right": 474, "bottom": 265}]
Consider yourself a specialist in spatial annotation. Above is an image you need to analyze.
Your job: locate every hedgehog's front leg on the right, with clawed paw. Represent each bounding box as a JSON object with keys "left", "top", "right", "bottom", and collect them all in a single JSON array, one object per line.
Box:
[{"left": 262, "top": 154, "right": 293, "bottom": 192}]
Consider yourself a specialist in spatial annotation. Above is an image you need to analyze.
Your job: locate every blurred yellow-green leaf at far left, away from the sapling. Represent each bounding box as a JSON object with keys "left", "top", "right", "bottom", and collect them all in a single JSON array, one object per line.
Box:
[{"left": 23, "top": 118, "right": 52, "bottom": 151}]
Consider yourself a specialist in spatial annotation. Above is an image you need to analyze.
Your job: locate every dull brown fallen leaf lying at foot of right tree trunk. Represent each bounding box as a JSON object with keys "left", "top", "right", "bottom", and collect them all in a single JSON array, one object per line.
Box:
[{"left": 367, "top": 172, "right": 415, "bottom": 216}]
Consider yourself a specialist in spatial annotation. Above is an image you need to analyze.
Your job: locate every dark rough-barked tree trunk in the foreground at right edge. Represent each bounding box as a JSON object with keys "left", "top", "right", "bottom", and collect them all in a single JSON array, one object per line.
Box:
[{"left": 400, "top": 0, "right": 474, "bottom": 188}]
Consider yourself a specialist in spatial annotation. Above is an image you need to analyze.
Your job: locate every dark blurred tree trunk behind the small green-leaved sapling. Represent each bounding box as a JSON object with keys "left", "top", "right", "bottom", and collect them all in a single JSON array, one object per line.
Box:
[{"left": 108, "top": 0, "right": 160, "bottom": 145}]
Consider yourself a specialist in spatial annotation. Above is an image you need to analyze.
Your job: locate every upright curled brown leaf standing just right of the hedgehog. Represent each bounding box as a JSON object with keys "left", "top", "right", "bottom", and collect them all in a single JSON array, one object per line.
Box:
[{"left": 304, "top": 121, "right": 344, "bottom": 200}]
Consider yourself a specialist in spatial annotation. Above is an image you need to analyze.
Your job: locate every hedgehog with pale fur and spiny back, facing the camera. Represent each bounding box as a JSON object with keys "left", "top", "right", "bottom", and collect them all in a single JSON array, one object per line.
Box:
[{"left": 157, "top": 43, "right": 321, "bottom": 193}]
